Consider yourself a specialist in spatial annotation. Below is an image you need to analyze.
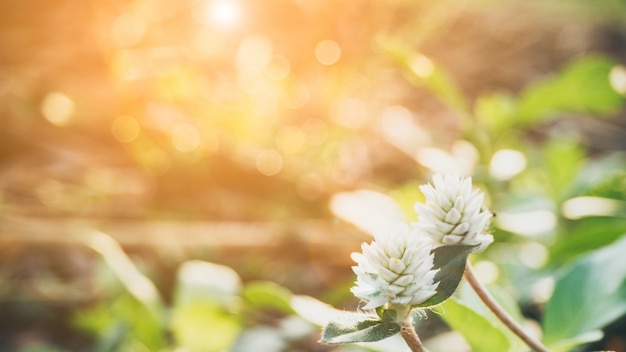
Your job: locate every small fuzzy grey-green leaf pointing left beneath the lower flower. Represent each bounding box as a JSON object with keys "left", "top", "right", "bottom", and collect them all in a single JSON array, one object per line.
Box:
[{"left": 322, "top": 313, "right": 401, "bottom": 344}]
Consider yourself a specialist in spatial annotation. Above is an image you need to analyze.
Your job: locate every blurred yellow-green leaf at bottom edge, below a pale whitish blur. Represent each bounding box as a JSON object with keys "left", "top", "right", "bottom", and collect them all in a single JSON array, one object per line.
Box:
[{"left": 172, "top": 301, "right": 241, "bottom": 352}]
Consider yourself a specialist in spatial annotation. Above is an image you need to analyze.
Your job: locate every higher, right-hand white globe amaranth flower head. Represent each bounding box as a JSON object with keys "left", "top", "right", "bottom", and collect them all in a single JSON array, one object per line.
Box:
[{"left": 415, "top": 174, "right": 493, "bottom": 251}]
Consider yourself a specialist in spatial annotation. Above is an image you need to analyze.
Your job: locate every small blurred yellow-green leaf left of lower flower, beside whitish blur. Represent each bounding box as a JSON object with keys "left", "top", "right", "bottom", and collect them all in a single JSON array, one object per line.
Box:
[{"left": 241, "top": 281, "right": 294, "bottom": 314}]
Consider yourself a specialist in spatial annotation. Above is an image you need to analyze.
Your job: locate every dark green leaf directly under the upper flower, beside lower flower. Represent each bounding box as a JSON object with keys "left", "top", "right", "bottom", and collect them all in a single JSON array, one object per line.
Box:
[{"left": 414, "top": 245, "right": 476, "bottom": 308}]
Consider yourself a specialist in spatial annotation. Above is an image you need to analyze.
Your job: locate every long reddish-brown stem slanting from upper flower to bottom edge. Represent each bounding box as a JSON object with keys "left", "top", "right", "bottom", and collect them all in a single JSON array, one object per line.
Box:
[{"left": 465, "top": 260, "right": 550, "bottom": 352}]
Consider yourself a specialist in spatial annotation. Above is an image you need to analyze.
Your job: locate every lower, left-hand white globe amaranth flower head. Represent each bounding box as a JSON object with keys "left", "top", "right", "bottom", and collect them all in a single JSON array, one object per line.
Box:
[{"left": 351, "top": 224, "right": 439, "bottom": 309}]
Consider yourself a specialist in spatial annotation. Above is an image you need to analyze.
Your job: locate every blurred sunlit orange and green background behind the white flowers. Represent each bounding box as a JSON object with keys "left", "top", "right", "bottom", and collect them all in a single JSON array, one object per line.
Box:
[{"left": 0, "top": 0, "right": 626, "bottom": 351}]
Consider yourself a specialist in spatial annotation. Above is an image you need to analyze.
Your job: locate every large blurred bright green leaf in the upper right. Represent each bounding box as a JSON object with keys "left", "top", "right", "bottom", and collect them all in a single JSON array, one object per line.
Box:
[{"left": 519, "top": 55, "right": 624, "bottom": 123}]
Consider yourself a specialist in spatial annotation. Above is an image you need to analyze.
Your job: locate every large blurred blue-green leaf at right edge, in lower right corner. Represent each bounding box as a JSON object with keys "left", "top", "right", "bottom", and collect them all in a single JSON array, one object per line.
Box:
[{"left": 543, "top": 236, "right": 626, "bottom": 351}]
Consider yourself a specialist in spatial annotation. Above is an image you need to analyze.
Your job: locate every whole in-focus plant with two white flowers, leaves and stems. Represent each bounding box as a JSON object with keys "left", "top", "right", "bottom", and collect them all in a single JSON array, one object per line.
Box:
[{"left": 322, "top": 175, "right": 547, "bottom": 352}]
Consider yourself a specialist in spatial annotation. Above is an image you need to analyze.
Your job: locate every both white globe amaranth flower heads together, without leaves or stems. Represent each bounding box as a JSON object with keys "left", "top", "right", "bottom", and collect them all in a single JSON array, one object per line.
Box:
[{"left": 351, "top": 175, "right": 493, "bottom": 309}]
